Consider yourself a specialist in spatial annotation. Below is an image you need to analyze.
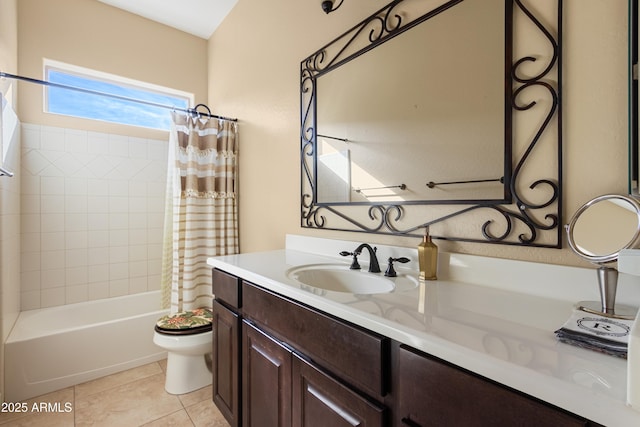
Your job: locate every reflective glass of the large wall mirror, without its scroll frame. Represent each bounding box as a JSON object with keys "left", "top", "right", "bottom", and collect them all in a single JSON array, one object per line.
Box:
[{"left": 316, "top": 0, "right": 504, "bottom": 203}]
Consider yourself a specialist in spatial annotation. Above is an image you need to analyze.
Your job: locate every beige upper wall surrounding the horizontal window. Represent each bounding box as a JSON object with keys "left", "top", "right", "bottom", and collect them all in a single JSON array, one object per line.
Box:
[{"left": 18, "top": 0, "right": 207, "bottom": 138}]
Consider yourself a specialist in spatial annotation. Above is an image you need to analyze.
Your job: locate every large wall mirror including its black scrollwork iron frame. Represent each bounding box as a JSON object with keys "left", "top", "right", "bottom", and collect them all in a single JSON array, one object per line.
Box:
[{"left": 300, "top": 0, "right": 562, "bottom": 247}]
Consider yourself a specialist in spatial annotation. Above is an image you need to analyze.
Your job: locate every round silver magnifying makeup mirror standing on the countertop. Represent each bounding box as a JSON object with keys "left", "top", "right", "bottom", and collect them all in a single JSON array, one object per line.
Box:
[{"left": 565, "top": 194, "right": 640, "bottom": 319}]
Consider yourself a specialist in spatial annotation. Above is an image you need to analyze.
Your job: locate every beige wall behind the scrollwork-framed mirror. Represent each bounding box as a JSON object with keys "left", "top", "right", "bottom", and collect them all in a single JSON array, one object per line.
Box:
[{"left": 209, "top": 0, "right": 627, "bottom": 265}]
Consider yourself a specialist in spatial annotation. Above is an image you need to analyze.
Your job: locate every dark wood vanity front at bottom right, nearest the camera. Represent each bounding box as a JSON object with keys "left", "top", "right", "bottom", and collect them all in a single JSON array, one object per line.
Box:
[{"left": 394, "top": 346, "right": 587, "bottom": 427}]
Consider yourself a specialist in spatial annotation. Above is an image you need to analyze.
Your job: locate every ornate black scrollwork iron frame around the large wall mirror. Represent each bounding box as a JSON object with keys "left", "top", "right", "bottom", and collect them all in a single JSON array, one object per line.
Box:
[{"left": 300, "top": 0, "right": 562, "bottom": 248}]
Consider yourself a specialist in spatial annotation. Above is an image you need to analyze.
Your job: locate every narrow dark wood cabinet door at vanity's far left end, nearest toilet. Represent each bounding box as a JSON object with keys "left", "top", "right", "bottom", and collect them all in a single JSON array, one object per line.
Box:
[{"left": 212, "top": 301, "right": 240, "bottom": 427}]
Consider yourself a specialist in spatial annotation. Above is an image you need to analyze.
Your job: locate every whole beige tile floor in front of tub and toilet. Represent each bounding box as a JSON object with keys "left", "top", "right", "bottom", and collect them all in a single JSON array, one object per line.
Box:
[{"left": 0, "top": 360, "right": 229, "bottom": 427}]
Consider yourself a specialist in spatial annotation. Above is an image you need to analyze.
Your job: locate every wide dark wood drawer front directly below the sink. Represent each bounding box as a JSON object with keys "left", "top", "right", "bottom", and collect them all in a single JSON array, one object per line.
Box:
[{"left": 242, "top": 282, "right": 389, "bottom": 399}]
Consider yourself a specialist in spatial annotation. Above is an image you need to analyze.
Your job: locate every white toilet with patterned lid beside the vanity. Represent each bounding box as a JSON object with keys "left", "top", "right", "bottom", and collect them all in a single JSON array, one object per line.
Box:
[{"left": 153, "top": 308, "right": 213, "bottom": 394}]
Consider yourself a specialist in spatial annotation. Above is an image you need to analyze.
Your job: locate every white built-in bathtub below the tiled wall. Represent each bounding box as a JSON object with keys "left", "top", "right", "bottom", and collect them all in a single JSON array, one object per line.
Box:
[{"left": 5, "top": 291, "right": 169, "bottom": 402}]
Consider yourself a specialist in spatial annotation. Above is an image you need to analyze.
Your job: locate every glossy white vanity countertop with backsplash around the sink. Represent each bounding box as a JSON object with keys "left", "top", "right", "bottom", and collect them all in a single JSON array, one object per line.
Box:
[{"left": 208, "top": 236, "right": 640, "bottom": 426}]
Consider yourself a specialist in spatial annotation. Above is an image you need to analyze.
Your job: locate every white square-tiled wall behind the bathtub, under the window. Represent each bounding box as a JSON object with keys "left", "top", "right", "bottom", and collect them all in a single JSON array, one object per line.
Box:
[{"left": 21, "top": 124, "right": 168, "bottom": 310}]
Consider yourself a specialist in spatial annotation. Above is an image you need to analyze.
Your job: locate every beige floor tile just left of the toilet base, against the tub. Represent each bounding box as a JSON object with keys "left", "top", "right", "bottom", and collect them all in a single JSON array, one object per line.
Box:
[{"left": 75, "top": 373, "right": 182, "bottom": 427}]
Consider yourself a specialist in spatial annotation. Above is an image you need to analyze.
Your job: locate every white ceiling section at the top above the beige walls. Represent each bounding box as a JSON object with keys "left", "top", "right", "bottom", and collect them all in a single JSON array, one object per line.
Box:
[{"left": 99, "top": 0, "right": 238, "bottom": 40}]
